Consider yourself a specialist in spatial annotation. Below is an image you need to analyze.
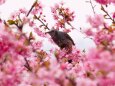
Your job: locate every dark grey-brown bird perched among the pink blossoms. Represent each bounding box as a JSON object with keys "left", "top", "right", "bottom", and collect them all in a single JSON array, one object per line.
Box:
[{"left": 46, "top": 29, "right": 75, "bottom": 53}]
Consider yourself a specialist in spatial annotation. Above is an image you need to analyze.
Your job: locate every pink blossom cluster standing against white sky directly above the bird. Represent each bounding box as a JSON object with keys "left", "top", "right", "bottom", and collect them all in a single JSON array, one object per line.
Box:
[{"left": 51, "top": 2, "right": 75, "bottom": 29}]
